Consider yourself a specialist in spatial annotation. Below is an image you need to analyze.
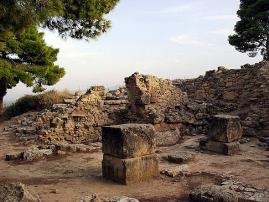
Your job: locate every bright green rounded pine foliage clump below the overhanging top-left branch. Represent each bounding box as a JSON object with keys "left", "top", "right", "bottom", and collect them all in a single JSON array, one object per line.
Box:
[{"left": 0, "top": 27, "right": 64, "bottom": 92}]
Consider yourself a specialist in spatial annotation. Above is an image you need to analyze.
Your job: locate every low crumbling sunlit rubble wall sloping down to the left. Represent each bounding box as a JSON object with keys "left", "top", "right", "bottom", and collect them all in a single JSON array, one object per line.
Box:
[{"left": 12, "top": 86, "right": 128, "bottom": 143}]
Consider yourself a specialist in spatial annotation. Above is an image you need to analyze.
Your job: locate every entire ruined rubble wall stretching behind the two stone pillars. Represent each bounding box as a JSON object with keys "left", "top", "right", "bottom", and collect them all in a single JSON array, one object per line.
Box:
[{"left": 2, "top": 62, "right": 269, "bottom": 151}]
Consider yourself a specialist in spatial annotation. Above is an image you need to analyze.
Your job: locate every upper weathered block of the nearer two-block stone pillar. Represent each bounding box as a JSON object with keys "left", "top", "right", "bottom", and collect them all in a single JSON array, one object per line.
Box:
[{"left": 102, "top": 124, "right": 156, "bottom": 159}]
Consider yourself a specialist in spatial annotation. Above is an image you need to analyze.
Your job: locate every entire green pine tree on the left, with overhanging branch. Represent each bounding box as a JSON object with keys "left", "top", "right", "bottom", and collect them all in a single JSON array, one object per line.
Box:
[{"left": 0, "top": 0, "right": 119, "bottom": 113}]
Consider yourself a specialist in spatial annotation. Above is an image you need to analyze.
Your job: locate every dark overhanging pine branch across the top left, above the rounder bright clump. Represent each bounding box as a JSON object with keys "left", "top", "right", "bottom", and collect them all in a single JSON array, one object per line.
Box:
[{"left": 0, "top": 0, "right": 119, "bottom": 39}]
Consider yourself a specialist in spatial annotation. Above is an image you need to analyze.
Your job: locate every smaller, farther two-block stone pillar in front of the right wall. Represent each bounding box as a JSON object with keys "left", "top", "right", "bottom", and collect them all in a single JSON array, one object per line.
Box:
[{"left": 200, "top": 114, "right": 242, "bottom": 155}]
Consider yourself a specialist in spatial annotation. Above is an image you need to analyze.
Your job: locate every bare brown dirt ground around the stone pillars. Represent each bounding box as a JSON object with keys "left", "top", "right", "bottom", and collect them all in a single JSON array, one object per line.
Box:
[{"left": 0, "top": 121, "right": 269, "bottom": 202}]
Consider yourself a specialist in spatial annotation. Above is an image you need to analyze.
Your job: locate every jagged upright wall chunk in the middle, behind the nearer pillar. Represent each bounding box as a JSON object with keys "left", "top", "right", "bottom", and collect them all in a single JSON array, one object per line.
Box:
[{"left": 125, "top": 73, "right": 187, "bottom": 146}]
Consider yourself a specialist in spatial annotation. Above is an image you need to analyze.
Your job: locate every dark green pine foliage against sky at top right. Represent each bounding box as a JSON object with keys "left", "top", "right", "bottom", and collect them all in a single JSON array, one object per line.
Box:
[{"left": 229, "top": 0, "right": 269, "bottom": 60}]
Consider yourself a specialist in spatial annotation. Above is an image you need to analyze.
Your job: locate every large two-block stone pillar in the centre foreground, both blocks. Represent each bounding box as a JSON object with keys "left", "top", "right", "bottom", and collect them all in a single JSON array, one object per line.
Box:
[{"left": 102, "top": 124, "right": 159, "bottom": 184}]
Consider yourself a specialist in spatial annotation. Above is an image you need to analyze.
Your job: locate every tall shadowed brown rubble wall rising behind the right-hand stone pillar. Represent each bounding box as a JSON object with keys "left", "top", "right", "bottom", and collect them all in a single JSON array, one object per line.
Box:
[{"left": 174, "top": 62, "right": 269, "bottom": 136}]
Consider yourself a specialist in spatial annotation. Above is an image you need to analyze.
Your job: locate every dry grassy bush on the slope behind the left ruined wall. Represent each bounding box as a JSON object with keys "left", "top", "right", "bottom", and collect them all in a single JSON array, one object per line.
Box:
[{"left": 4, "top": 90, "right": 71, "bottom": 119}]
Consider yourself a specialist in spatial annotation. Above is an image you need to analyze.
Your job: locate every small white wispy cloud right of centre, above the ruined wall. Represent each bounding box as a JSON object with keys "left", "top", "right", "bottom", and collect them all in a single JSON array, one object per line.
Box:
[{"left": 170, "top": 35, "right": 213, "bottom": 46}]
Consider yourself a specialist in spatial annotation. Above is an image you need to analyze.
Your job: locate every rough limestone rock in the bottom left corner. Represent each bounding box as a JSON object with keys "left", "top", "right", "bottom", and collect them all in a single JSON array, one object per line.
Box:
[{"left": 0, "top": 183, "right": 40, "bottom": 202}]
